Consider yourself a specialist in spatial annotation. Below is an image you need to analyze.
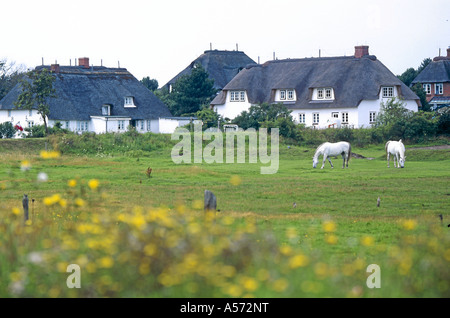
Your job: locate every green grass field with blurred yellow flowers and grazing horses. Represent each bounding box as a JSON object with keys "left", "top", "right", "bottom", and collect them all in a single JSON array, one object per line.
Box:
[{"left": 0, "top": 135, "right": 450, "bottom": 297}]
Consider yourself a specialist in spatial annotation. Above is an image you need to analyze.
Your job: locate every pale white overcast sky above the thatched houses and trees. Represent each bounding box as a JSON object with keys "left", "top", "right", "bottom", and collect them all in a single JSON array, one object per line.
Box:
[{"left": 0, "top": 0, "right": 450, "bottom": 86}]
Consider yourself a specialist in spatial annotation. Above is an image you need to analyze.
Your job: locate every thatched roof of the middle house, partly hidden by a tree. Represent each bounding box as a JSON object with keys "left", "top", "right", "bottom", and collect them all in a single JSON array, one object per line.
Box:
[{"left": 164, "top": 50, "right": 255, "bottom": 89}]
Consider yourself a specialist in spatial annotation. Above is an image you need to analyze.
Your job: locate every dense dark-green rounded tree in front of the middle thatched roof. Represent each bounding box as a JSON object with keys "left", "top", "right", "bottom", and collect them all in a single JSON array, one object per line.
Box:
[{"left": 170, "top": 64, "right": 216, "bottom": 116}]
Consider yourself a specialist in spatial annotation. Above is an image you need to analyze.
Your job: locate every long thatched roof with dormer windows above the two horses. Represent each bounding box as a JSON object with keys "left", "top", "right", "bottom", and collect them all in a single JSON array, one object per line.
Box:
[{"left": 211, "top": 55, "right": 419, "bottom": 109}]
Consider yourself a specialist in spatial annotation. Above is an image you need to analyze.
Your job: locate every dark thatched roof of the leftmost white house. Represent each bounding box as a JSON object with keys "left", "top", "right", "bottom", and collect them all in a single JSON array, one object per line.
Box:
[{"left": 0, "top": 66, "right": 172, "bottom": 121}]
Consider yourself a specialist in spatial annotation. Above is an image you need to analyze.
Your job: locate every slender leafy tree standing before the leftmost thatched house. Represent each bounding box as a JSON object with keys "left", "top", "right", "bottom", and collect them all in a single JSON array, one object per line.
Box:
[{"left": 14, "top": 68, "right": 56, "bottom": 134}]
